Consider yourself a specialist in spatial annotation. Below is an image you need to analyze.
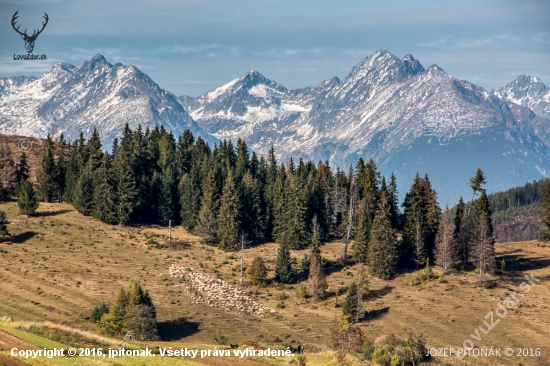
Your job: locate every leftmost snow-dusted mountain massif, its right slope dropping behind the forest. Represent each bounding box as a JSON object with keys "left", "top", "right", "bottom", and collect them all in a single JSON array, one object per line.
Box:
[{"left": 0, "top": 55, "right": 216, "bottom": 146}]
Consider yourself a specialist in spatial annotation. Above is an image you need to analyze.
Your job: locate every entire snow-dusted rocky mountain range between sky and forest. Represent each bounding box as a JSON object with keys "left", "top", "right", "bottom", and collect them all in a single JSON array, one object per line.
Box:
[{"left": 0, "top": 51, "right": 550, "bottom": 204}]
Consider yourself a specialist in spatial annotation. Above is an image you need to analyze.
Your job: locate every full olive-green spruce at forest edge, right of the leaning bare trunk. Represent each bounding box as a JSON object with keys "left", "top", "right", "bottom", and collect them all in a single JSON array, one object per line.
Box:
[{"left": 368, "top": 193, "right": 398, "bottom": 278}]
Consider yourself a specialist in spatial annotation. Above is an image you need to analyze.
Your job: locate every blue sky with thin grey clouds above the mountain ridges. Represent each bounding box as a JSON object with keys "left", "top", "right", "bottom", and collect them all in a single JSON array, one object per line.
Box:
[{"left": 0, "top": 0, "right": 550, "bottom": 96}]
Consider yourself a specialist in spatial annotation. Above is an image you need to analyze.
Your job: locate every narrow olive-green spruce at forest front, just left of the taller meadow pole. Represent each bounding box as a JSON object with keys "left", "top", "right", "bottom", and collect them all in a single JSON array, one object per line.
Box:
[{"left": 217, "top": 172, "right": 240, "bottom": 251}]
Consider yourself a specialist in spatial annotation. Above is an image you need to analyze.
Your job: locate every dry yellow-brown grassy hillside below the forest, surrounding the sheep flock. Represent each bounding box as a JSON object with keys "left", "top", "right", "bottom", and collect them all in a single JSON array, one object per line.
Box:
[{"left": 0, "top": 202, "right": 550, "bottom": 365}]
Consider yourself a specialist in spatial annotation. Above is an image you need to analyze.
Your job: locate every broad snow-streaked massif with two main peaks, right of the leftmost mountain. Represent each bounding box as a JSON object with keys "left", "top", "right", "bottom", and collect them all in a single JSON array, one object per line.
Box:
[{"left": 179, "top": 51, "right": 550, "bottom": 202}]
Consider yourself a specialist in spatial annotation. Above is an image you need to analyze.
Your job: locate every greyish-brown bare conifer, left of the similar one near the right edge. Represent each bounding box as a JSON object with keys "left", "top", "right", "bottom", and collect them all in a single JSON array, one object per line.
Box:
[{"left": 435, "top": 205, "right": 458, "bottom": 271}]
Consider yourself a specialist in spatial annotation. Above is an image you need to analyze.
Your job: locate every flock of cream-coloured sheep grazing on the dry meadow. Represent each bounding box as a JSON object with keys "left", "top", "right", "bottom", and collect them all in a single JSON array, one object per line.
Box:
[{"left": 170, "top": 264, "right": 275, "bottom": 317}]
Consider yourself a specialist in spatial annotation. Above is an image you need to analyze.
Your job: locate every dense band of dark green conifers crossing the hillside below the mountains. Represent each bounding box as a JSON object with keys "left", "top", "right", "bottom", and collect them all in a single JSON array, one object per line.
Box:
[{"left": 32, "top": 125, "right": 500, "bottom": 282}]
